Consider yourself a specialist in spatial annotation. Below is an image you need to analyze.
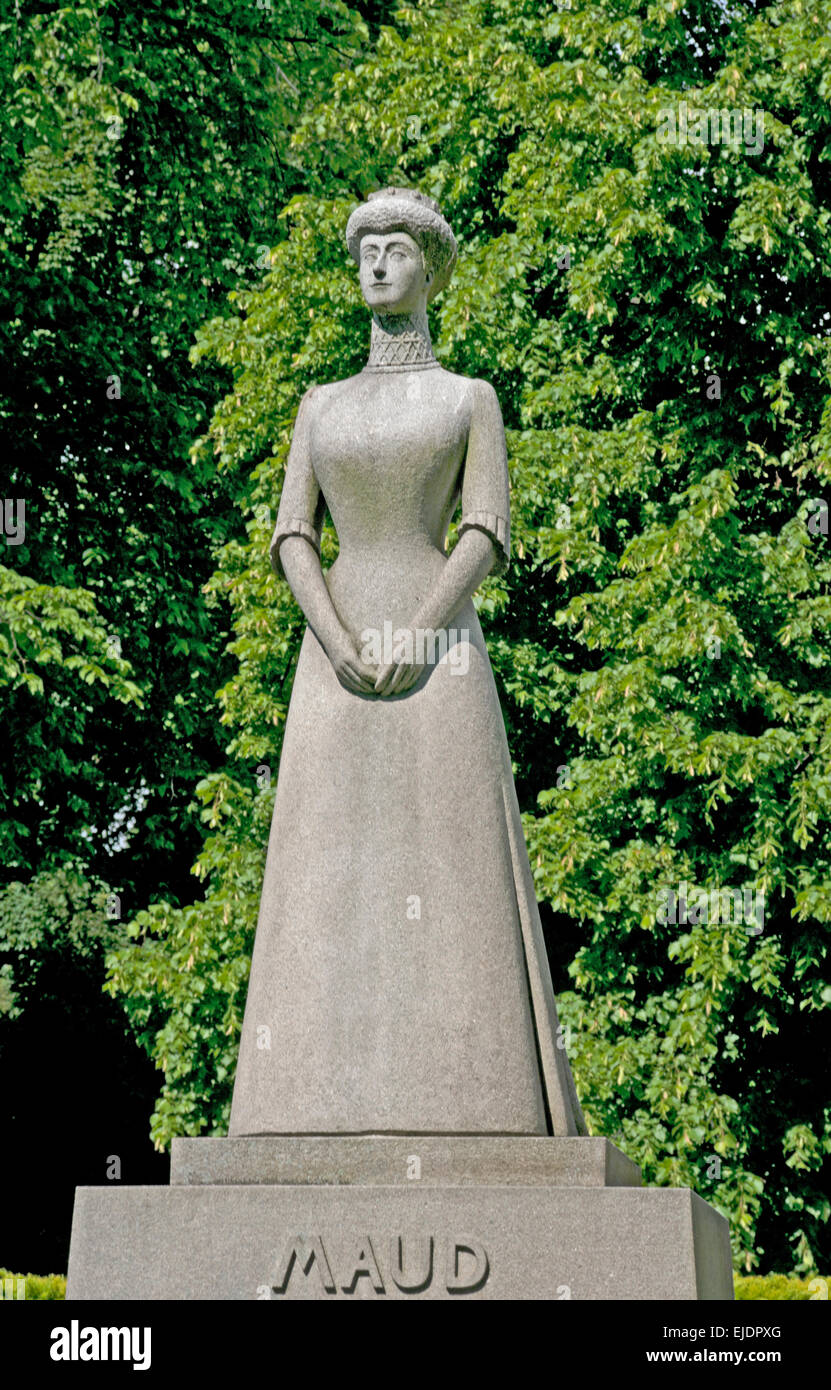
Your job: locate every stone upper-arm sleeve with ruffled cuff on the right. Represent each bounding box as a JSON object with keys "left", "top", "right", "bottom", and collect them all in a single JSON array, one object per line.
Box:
[{"left": 459, "top": 381, "right": 511, "bottom": 574}]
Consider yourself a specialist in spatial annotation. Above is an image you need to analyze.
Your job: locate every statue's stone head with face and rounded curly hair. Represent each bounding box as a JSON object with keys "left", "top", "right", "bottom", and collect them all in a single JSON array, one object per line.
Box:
[{"left": 346, "top": 188, "right": 456, "bottom": 314}]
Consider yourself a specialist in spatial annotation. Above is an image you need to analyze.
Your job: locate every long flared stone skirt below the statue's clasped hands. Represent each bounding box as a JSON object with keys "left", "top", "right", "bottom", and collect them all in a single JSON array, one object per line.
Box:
[{"left": 231, "top": 603, "right": 585, "bottom": 1134}]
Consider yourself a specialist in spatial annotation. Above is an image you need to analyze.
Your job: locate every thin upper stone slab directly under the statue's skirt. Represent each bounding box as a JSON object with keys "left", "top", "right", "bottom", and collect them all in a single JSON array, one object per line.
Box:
[{"left": 171, "top": 1134, "right": 641, "bottom": 1187}]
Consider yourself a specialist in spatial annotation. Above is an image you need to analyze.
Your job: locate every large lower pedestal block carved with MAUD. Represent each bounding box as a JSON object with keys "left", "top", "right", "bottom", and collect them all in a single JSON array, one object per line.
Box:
[{"left": 68, "top": 1183, "right": 732, "bottom": 1300}]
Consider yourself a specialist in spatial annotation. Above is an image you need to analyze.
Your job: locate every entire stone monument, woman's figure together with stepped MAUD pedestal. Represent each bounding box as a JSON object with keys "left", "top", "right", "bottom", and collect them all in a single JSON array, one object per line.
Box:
[{"left": 67, "top": 189, "right": 732, "bottom": 1301}]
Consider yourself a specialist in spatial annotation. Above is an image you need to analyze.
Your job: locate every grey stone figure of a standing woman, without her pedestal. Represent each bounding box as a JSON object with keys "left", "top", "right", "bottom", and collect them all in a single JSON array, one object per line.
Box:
[{"left": 231, "top": 188, "right": 585, "bottom": 1134}]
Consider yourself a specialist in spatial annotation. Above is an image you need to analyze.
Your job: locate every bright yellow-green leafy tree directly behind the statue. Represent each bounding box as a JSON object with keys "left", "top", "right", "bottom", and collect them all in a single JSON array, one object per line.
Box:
[{"left": 100, "top": 0, "right": 831, "bottom": 1273}]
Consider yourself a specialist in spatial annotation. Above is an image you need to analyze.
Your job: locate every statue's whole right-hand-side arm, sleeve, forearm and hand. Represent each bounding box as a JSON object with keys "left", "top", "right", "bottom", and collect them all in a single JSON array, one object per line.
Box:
[{"left": 375, "top": 381, "right": 510, "bottom": 695}]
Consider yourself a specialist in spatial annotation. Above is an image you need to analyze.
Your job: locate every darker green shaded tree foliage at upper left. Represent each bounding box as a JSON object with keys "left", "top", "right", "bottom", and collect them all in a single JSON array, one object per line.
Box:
[{"left": 0, "top": 0, "right": 365, "bottom": 895}]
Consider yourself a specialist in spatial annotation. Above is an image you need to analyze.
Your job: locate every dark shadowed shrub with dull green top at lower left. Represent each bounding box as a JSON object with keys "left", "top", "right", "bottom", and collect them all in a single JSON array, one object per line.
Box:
[{"left": 0, "top": 862, "right": 167, "bottom": 1269}]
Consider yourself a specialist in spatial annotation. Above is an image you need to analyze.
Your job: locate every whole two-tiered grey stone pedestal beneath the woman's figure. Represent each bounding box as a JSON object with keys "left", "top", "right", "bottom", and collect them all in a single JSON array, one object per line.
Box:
[{"left": 67, "top": 1136, "right": 732, "bottom": 1300}]
